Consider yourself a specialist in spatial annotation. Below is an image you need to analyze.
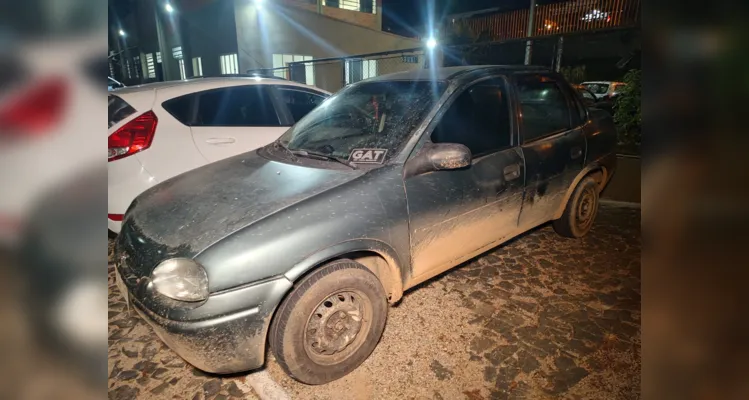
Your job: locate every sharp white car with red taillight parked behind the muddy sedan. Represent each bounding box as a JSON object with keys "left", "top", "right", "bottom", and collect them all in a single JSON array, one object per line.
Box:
[{"left": 107, "top": 77, "right": 330, "bottom": 233}]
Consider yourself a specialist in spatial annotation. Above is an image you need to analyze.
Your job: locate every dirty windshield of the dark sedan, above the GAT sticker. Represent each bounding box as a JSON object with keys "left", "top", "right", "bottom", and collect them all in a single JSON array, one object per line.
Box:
[{"left": 280, "top": 81, "right": 447, "bottom": 161}]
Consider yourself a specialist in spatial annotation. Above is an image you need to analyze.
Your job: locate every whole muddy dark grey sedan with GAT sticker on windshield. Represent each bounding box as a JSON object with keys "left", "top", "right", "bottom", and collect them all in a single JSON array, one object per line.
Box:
[{"left": 117, "top": 66, "right": 615, "bottom": 384}]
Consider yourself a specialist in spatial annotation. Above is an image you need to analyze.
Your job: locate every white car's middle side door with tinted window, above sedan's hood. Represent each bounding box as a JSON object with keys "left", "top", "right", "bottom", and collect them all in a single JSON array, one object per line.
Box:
[{"left": 190, "top": 85, "right": 291, "bottom": 162}]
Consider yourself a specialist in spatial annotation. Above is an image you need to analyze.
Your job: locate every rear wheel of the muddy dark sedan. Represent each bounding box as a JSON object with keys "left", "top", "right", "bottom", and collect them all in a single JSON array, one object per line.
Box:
[{"left": 553, "top": 176, "right": 598, "bottom": 238}]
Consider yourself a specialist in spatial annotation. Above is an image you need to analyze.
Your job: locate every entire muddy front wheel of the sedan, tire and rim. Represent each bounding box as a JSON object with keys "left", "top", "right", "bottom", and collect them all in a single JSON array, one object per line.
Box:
[{"left": 269, "top": 260, "right": 388, "bottom": 385}]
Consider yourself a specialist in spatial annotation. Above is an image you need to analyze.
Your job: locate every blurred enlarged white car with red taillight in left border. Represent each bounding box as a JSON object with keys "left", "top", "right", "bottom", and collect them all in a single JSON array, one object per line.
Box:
[{"left": 0, "top": 37, "right": 103, "bottom": 248}]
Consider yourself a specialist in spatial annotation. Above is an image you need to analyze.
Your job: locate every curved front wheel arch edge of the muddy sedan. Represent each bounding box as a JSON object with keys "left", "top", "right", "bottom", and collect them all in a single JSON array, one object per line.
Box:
[{"left": 284, "top": 239, "right": 404, "bottom": 303}]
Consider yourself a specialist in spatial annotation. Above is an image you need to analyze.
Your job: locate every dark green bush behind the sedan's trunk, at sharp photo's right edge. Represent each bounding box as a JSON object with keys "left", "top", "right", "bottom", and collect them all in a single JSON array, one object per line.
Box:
[{"left": 614, "top": 69, "right": 642, "bottom": 146}]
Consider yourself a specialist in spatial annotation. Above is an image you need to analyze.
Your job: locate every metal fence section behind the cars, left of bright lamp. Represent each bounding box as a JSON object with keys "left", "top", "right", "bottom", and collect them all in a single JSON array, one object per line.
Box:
[{"left": 247, "top": 49, "right": 429, "bottom": 92}]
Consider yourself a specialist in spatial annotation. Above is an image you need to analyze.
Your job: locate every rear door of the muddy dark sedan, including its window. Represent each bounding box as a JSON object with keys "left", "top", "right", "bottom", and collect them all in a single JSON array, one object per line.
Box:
[{"left": 514, "top": 74, "right": 586, "bottom": 230}]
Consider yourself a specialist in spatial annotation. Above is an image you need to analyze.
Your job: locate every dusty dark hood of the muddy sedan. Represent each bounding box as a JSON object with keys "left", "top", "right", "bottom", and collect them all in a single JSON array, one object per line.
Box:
[{"left": 119, "top": 151, "right": 364, "bottom": 267}]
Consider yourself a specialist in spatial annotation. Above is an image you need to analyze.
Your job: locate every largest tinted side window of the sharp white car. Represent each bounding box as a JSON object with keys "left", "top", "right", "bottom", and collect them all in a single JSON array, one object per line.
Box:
[{"left": 193, "top": 85, "right": 281, "bottom": 126}]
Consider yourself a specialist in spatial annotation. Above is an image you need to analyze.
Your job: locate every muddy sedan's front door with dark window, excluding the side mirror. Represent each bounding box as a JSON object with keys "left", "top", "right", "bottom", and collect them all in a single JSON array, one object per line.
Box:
[{"left": 405, "top": 78, "right": 525, "bottom": 283}]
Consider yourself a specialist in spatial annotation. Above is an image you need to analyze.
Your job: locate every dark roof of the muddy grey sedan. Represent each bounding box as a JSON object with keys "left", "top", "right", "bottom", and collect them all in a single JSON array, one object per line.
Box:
[{"left": 367, "top": 65, "right": 550, "bottom": 82}]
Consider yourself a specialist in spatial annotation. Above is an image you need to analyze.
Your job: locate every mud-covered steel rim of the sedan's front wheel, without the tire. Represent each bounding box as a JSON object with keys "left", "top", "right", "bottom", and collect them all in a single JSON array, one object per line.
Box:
[{"left": 304, "top": 289, "right": 372, "bottom": 365}]
